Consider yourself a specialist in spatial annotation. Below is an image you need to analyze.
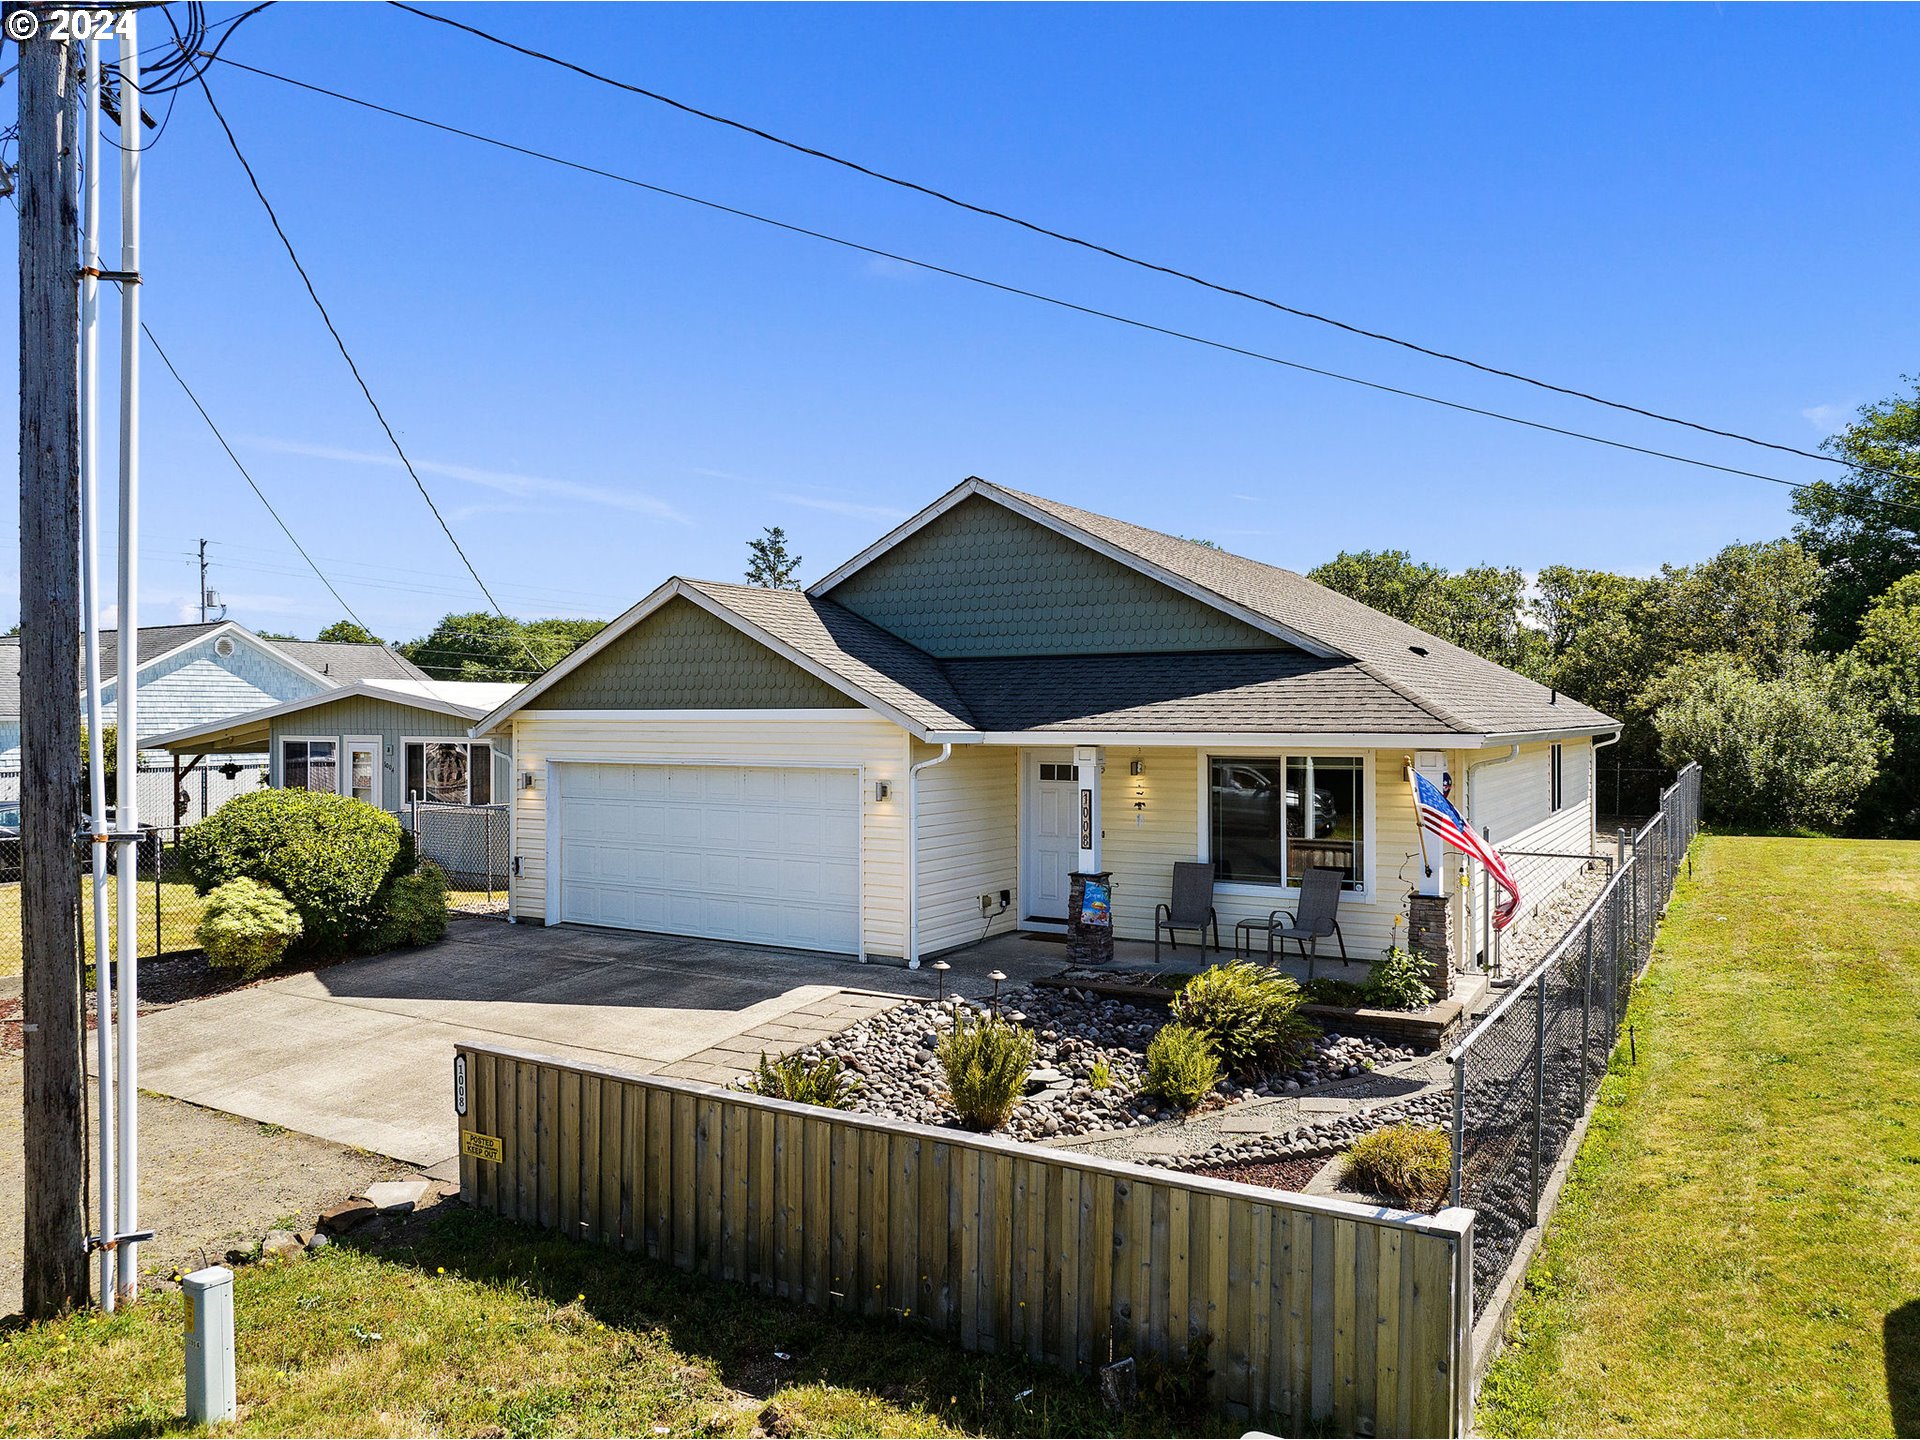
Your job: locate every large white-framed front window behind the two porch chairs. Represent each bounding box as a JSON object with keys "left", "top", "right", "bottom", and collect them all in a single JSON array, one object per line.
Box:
[{"left": 1208, "top": 755, "right": 1367, "bottom": 889}]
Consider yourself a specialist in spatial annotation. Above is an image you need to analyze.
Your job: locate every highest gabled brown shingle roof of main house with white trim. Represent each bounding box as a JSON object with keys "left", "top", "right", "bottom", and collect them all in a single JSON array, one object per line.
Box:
[{"left": 808, "top": 478, "right": 1619, "bottom": 735}]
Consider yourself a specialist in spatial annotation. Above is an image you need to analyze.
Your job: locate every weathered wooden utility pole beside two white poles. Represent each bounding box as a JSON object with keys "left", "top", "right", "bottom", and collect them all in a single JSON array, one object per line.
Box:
[{"left": 10, "top": 6, "right": 88, "bottom": 1317}]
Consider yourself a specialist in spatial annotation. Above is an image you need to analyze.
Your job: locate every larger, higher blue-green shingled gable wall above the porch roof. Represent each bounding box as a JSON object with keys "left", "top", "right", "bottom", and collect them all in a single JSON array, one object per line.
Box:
[{"left": 828, "top": 497, "right": 1288, "bottom": 659}]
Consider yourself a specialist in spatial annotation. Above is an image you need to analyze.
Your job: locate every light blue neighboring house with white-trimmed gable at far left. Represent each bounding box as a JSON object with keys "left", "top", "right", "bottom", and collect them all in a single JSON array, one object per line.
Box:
[{"left": 0, "top": 620, "right": 424, "bottom": 770}]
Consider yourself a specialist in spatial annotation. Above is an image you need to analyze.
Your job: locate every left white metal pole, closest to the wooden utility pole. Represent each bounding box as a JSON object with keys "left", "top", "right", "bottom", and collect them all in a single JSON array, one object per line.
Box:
[{"left": 81, "top": 28, "right": 117, "bottom": 1309}]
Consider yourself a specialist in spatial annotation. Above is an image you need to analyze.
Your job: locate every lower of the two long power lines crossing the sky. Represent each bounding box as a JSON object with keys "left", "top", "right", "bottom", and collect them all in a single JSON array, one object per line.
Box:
[{"left": 206, "top": 54, "right": 1920, "bottom": 515}]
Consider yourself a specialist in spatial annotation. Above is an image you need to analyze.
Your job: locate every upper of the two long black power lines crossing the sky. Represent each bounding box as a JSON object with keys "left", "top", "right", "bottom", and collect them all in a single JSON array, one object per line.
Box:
[{"left": 388, "top": 0, "right": 1897, "bottom": 487}]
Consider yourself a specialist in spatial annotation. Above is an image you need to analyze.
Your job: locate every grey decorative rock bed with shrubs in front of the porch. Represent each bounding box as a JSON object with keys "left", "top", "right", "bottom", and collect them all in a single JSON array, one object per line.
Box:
[{"left": 771, "top": 987, "right": 1411, "bottom": 1140}]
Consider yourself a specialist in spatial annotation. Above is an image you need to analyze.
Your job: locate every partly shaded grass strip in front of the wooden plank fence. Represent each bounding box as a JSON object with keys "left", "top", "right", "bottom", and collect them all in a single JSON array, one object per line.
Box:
[{"left": 0, "top": 1206, "right": 1221, "bottom": 1436}]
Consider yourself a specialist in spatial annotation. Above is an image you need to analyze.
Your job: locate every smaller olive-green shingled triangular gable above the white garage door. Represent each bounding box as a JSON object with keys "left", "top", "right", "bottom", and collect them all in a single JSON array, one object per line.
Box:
[{"left": 528, "top": 599, "right": 858, "bottom": 710}]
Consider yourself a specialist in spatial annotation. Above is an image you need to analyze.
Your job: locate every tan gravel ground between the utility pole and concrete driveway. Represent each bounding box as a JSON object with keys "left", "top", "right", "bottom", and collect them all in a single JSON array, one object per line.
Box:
[{"left": 0, "top": 1054, "right": 415, "bottom": 1315}]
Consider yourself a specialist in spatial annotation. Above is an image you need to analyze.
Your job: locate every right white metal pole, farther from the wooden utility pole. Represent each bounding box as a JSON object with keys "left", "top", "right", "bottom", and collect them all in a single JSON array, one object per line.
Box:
[{"left": 113, "top": 10, "right": 142, "bottom": 1298}]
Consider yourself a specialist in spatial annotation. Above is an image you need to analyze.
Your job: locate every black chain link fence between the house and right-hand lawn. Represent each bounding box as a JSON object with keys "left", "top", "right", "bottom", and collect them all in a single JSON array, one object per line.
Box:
[{"left": 1448, "top": 764, "right": 1699, "bottom": 1309}]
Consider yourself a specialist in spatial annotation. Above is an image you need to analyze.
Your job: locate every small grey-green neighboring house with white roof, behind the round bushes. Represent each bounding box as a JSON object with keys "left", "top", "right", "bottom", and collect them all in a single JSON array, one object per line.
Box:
[{"left": 144, "top": 678, "right": 518, "bottom": 810}]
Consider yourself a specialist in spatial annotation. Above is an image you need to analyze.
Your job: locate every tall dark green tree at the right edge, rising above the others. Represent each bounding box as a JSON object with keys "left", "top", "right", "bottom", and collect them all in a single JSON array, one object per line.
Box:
[{"left": 1793, "top": 384, "right": 1920, "bottom": 653}]
